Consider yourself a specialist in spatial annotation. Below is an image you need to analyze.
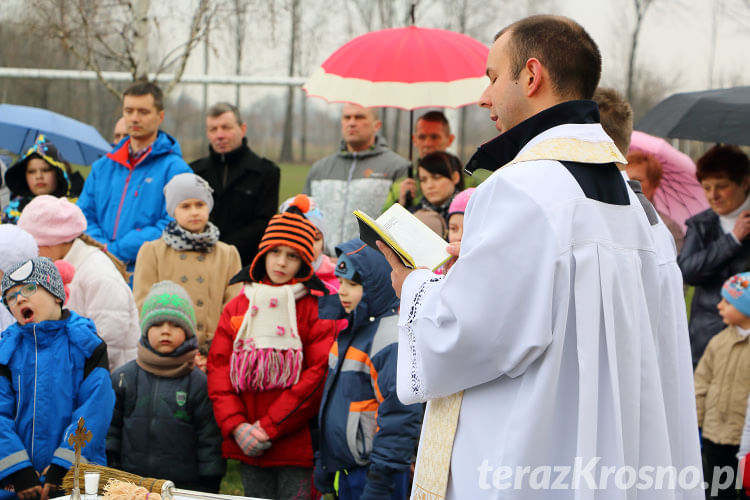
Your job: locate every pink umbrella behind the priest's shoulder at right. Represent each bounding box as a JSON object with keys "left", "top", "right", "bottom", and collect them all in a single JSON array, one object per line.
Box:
[{"left": 628, "top": 131, "right": 708, "bottom": 230}]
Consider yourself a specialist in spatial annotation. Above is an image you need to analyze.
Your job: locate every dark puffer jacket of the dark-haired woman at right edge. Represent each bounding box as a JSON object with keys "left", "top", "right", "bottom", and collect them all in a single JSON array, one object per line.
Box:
[{"left": 677, "top": 209, "right": 750, "bottom": 366}]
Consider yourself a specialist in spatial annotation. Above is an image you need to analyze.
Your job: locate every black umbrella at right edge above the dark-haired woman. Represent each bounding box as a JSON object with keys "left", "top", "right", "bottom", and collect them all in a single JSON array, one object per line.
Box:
[{"left": 635, "top": 87, "right": 750, "bottom": 146}]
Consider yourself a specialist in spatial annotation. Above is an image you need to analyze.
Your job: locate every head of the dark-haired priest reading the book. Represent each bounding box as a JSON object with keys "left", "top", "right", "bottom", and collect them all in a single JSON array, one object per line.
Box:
[{"left": 479, "top": 16, "right": 602, "bottom": 133}]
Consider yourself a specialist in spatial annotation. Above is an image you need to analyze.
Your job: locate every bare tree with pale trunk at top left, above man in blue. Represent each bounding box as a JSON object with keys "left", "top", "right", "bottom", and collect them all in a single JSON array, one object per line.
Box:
[{"left": 31, "top": 0, "right": 218, "bottom": 97}]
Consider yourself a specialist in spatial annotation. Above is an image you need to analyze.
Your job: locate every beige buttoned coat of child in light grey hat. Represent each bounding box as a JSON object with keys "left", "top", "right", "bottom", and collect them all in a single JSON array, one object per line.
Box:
[{"left": 133, "top": 239, "right": 242, "bottom": 345}]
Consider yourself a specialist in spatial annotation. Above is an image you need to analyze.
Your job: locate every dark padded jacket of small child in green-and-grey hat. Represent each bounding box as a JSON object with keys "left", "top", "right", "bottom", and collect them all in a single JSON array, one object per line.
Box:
[{"left": 107, "top": 352, "right": 225, "bottom": 489}]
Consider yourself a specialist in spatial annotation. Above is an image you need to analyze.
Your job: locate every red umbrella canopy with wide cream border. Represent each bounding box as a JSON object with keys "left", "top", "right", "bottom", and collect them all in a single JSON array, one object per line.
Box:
[{"left": 303, "top": 26, "right": 489, "bottom": 110}]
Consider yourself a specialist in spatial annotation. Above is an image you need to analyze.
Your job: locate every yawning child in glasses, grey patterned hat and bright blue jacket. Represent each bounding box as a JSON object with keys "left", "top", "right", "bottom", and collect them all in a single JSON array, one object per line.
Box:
[{"left": 0, "top": 257, "right": 115, "bottom": 499}]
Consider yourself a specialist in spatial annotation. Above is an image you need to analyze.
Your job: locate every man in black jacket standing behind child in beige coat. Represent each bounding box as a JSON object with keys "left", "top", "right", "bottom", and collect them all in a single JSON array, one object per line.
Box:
[{"left": 190, "top": 102, "right": 281, "bottom": 266}]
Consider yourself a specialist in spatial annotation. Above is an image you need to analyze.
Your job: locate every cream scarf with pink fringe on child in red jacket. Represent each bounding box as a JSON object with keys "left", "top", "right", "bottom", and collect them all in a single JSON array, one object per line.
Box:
[{"left": 229, "top": 283, "right": 308, "bottom": 393}]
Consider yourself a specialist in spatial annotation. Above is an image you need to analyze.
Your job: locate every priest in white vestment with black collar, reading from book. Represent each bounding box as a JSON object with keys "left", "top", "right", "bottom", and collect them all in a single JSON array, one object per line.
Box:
[{"left": 383, "top": 16, "right": 703, "bottom": 500}]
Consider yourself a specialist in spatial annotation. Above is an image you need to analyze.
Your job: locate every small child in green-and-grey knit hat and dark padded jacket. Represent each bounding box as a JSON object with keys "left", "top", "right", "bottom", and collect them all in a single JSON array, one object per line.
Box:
[{"left": 107, "top": 281, "right": 225, "bottom": 493}]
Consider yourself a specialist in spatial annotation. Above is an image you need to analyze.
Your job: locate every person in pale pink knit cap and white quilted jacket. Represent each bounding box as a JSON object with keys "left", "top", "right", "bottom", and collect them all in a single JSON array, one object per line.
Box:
[{"left": 18, "top": 195, "right": 141, "bottom": 370}]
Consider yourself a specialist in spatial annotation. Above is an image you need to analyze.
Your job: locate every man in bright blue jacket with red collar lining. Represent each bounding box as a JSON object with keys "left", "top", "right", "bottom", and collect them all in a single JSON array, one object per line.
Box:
[{"left": 78, "top": 82, "right": 192, "bottom": 272}]
